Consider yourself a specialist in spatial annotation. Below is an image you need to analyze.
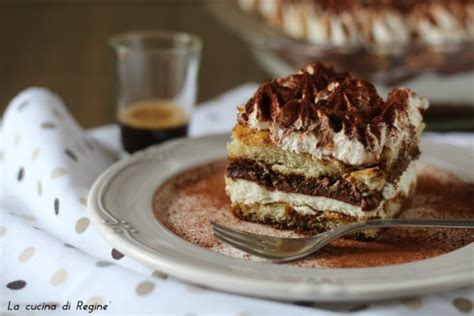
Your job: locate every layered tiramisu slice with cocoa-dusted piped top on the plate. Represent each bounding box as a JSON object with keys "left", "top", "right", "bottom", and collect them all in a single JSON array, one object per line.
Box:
[{"left": 226, "top": 63, "right": 428, "bottom": 237}]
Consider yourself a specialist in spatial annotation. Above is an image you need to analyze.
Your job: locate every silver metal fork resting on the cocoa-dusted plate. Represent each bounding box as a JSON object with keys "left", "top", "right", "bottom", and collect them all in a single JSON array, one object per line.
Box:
[{"left": 211, "top": 219, "right": 474, "bottom": 262}]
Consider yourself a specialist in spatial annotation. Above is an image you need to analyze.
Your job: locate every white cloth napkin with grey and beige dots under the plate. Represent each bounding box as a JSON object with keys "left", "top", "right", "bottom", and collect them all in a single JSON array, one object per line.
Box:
[{"left": 0, "top": 84, "right": 474, "bottom": 315}]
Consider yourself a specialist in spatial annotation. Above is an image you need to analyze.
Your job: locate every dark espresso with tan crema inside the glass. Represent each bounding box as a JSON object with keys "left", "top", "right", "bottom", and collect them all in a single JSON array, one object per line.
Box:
[{"left": 119, "top": 100, "right": 189, "bottom": 153}]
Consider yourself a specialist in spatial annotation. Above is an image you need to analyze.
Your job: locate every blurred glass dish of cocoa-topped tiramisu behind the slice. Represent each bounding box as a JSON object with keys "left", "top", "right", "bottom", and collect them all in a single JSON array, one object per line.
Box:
[{"left": 205, "top": 0, "right": 474, "bottom": 116}]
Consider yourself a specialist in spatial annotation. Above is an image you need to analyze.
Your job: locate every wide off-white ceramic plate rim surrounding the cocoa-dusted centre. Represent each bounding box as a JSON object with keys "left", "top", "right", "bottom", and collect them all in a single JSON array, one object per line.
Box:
[{"left": 88, "top": 135, "right": 474, "bottom": 302}]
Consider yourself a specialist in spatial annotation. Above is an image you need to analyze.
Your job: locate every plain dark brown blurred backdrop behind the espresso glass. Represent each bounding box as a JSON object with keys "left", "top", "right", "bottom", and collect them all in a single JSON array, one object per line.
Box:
[{"left": 0, "top": 0, "right": 268, "bottom": 127}]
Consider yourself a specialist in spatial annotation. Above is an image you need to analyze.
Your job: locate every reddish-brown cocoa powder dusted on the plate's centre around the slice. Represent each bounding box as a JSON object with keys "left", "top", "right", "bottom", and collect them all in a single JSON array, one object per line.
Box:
[{"left": 154, "top": 161, "right": 474, "bottom": 268}]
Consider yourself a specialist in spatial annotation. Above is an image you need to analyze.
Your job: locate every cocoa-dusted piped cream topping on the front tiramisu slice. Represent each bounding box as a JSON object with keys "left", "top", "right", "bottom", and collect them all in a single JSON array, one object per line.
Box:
[{"left": 238, "top": 64, "right": 428, "bottom": 166}]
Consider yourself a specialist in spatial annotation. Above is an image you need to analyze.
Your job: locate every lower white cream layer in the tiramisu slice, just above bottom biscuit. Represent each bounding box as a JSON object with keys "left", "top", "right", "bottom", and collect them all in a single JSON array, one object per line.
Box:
[{"left": 226, "top": 161, "right": 416, "bottom": 217}]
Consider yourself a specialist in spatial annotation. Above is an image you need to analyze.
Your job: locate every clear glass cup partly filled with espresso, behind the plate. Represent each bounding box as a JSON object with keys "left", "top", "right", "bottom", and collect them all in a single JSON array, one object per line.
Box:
[{"left": 109, "top": 31, "right": 202, "bottom": 153}]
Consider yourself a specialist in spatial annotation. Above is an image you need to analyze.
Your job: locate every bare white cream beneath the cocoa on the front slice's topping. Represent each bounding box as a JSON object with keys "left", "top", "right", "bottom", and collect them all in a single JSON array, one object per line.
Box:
[{"left": 247, "top": 90, "right": 428, "bottom": 166}]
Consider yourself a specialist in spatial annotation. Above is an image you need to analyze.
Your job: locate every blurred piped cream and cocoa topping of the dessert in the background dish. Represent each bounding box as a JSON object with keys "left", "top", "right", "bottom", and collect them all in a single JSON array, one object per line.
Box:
[{"left": 239, "top": 0, "right": 474, "bottom": 46}]
